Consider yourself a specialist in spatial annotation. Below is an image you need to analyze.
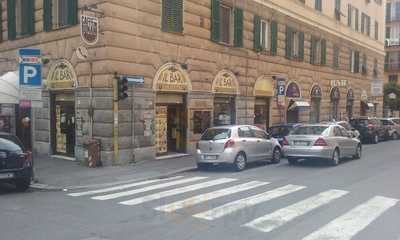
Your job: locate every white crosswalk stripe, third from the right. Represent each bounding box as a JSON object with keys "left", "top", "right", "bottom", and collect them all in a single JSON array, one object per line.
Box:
[{"left": 193, "top": 185, "right": 306, "bottom": 220}]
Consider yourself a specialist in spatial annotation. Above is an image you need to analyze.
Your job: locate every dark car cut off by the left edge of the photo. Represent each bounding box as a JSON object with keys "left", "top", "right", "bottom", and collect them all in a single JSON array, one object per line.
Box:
[{"left": 0, "top": 133, "right": 33, "bottom": 191}]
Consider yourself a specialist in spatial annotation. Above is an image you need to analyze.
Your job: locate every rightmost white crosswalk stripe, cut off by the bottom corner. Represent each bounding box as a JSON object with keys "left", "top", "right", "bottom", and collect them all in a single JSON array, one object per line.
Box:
[{"left": 303, "top": 196, "right": 399, "bottom": 240}]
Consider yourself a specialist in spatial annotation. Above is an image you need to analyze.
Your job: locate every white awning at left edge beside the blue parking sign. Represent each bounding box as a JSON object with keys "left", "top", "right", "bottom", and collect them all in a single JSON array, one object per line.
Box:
[{"left": 0, "top": 72, "right": 19, "bottom": 104}]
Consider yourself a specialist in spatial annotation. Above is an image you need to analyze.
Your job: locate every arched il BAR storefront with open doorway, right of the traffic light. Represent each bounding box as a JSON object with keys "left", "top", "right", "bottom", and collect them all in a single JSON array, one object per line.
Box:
[{"left": 153, "top": 63, "right": 191, "bottom": 156}]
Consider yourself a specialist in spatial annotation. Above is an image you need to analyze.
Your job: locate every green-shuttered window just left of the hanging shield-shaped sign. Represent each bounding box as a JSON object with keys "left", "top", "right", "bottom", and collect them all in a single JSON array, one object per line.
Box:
[{"left": 43, "top": 0, "right": 78, "bottom": 32}]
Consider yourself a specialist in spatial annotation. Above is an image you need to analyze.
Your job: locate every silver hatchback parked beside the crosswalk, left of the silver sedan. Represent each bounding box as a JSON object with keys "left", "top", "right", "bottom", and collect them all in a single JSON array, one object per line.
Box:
[{"left": 196, "top": 125, "right": 281, "bottom": 171}]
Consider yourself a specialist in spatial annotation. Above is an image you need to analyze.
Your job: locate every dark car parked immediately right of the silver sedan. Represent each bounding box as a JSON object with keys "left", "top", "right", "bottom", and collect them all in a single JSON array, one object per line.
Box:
[{"left": 350, "top": 117, "right": 388, "bottom": 144}]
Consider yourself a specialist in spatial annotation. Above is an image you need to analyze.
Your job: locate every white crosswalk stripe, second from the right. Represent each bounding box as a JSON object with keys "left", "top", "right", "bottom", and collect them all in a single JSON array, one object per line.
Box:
[{"left": 243, "top": 190, "right": 348, "bottom": 232}]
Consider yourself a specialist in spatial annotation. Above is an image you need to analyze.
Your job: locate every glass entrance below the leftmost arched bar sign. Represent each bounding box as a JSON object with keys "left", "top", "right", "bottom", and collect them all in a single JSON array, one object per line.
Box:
[{"left": 52, "top": 95, "right": 75, "bottom": 157}]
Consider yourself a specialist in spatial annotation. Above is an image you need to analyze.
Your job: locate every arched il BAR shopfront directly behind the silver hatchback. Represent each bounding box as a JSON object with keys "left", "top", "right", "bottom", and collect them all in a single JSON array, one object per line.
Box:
[{"left": 212, "top": 70, "right": 239, "bottom": 126}]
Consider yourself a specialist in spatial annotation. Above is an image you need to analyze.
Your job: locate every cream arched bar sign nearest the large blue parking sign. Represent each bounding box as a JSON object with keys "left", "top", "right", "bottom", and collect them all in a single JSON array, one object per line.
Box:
[{"left": 47, "top": 60, "right": 77, "bottom": 89}]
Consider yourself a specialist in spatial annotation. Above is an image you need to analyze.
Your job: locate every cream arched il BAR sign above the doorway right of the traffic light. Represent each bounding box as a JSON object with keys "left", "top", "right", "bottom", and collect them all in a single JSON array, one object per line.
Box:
[{"left": 156, "top": 66, "right": 188, "bottom": 92}]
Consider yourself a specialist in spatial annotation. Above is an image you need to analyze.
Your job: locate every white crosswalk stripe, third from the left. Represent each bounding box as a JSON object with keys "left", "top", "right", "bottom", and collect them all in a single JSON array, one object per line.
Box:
[{"left": 119, "top": 178, "right": 237, "bottom": 206}]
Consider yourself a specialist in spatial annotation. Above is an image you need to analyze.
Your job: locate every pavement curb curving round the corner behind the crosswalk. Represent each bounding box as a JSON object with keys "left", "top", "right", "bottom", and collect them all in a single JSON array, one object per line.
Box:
[{"left": 31, "top": 166, "right": 197, "bottom": 192}]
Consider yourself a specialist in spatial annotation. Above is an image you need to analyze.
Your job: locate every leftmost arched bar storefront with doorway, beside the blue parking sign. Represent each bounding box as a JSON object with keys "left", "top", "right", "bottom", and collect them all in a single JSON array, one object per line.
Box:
[{"left": 46, "top": 60, "right": 77, "bottom": 157}]
